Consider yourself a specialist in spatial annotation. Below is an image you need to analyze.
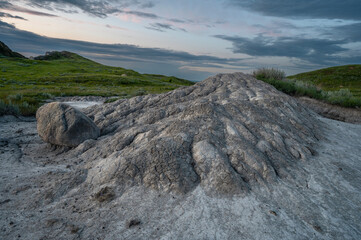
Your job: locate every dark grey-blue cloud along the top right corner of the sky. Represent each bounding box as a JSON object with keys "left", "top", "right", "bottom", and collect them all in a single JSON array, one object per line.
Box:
[{"left": 228, "top": 0, "right": 361, "bottom": 20}]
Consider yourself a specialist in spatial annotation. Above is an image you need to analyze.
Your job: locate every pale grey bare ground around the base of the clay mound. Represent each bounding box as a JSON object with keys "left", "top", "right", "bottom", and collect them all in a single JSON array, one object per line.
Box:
[{"left": 0, "top": 104, "right": 361, "bottom": 239}]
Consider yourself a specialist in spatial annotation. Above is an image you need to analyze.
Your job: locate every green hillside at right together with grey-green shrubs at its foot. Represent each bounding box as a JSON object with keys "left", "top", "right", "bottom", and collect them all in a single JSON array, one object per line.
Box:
[{"left": 253, "top": 65, "right": 361, "bottom": 108}]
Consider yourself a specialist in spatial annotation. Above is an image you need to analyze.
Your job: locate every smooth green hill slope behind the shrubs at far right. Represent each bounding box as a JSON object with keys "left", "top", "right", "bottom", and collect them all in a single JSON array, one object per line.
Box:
[{"left": 287, "top": 64, "right": 361, "bottom": 97}]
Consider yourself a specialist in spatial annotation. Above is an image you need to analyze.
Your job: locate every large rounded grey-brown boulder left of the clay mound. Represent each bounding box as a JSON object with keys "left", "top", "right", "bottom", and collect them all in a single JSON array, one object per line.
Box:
[{"left": 36, "top": 102, "right": 100, "bottom": 147}]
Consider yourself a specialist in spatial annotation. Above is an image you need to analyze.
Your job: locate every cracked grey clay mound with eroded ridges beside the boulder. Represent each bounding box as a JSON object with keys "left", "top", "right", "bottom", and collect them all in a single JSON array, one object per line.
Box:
[{"left": 80, "top": 73, "right": 317, "bottom": 194}]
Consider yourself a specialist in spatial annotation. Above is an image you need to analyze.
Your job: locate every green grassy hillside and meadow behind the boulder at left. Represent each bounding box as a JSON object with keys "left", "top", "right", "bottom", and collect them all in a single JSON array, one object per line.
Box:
[{"left": 0, "top": 54, "right": 194, "bottom": 115}]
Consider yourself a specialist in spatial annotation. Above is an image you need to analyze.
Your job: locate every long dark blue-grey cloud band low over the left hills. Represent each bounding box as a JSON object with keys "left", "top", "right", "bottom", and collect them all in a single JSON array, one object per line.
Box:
[{"left": 0, "top": 18, "right": 245, "bottom": 81}]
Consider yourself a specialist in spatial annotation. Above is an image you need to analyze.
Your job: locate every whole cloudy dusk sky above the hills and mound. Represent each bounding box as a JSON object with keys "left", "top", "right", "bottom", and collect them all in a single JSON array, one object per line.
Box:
[{"left": 0, "top": 0, "right": 361, "bottom": 81}]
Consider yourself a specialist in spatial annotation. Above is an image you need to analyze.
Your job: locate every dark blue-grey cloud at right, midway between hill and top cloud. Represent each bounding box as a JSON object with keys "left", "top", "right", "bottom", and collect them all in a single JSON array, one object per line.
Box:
[{"left": 215, "top": 35, "right": 361, "bottom": 64}]
